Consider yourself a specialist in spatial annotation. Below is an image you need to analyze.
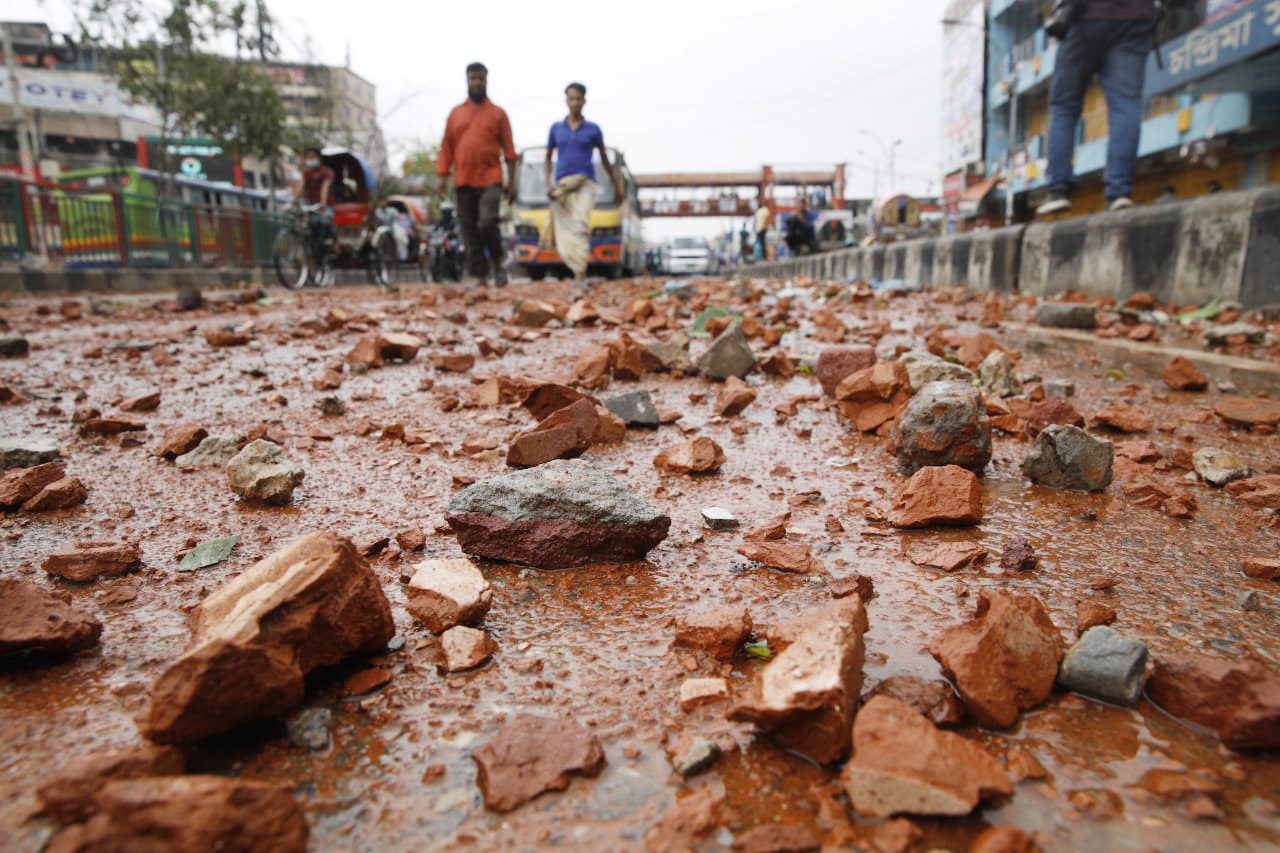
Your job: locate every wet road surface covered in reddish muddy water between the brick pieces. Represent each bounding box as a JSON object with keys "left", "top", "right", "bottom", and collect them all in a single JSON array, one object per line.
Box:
[{"left": 0, "top": 283, "right": 1280, "bottom": 850}]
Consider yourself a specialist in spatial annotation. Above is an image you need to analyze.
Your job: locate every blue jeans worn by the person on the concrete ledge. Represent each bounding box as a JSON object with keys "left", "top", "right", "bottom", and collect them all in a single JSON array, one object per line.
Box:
[{"left": 1048, "top": 18, "right": 1153, "bottom": 200}]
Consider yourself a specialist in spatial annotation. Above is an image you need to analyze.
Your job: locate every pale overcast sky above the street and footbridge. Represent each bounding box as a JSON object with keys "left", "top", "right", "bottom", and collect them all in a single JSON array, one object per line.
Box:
[{"left": 12, "top": 0, "right": 945, "bottom": 232}]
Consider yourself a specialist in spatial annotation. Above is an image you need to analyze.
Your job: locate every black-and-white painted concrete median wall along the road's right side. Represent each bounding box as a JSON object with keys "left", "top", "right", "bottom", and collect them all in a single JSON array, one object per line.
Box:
[{"left": 741, "top": 187, "right": 1280, "bottom": 307}]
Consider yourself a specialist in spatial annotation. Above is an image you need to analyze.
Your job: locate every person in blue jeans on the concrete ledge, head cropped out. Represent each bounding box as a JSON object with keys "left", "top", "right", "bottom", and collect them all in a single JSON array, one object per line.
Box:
[{"left": 1036, "top": 0, "right": 1156, "bottom": 215}]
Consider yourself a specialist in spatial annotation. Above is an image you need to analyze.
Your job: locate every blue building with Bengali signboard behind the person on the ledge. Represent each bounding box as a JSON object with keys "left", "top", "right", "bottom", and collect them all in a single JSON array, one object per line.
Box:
[{"left": 943, "top": 0, "right": 1280, "bottom": 228}]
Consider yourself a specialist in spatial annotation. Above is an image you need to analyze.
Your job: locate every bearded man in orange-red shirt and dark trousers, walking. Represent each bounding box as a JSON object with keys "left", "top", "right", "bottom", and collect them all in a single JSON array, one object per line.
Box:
[{"left": 435, "top": 63, "right": 516, "bottom": 287}]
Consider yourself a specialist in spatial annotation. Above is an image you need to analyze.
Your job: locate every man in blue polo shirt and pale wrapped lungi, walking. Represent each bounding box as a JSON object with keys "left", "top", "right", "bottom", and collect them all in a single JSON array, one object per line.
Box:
[{"left": 540, "top": 83, "right": 626, "bottom": 284}]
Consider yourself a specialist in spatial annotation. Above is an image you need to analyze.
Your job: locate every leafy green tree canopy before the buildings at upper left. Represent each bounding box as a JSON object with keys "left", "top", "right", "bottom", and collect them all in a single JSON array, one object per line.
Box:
[{"left": 74, "top": 0, "right": 285, "bottom": 163}]
